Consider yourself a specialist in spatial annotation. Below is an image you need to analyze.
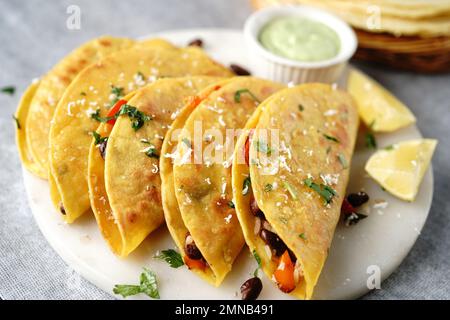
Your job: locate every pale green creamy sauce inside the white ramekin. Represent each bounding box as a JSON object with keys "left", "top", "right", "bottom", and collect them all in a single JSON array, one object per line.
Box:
[{"left": 259, "top": 17, "right": 341, "bottom": 62}]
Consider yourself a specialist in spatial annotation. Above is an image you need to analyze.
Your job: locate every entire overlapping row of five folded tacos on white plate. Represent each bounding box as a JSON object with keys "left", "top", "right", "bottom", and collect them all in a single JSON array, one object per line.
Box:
[{"left": 16, "top": 37, "right": 358, "bottom": 299}]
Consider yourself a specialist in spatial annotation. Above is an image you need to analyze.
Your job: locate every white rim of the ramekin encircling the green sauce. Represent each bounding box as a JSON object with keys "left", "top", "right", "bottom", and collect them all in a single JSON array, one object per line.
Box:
[{"left": 244, "top": 5, "right": 358, "bottom": 69}]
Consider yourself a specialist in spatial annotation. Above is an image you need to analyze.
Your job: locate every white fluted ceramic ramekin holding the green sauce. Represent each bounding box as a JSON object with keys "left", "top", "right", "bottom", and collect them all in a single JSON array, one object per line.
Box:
[{"left": 244, "top": 5, "right": 358, "bottom": 84}]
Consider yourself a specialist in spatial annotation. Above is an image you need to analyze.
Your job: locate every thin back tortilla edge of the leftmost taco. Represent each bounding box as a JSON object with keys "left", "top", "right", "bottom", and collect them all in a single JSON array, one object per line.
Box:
[{"left": 15, "top": 81, "right": 43, "bottom": 179}]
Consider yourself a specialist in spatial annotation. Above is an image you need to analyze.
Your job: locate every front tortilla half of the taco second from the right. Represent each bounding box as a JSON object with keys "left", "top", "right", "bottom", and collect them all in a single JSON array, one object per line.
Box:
[{"left": 169, "top": 77, "right": 284, "bottom": 286}]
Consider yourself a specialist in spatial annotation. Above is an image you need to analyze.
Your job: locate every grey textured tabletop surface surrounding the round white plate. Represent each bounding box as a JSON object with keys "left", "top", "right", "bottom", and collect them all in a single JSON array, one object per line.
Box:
[{"left": 0, "top": 0, "right": 450, "bottom": 299}]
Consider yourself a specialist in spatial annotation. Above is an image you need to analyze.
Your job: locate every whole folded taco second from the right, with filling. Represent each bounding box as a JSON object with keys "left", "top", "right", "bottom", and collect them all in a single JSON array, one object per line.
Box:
[{"left": 160, "top": 77, "right": 284, "bottom": 286}]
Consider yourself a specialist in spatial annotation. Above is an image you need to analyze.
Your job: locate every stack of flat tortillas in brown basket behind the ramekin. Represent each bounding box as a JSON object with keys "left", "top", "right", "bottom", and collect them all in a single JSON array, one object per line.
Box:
[{"left": 252, "top": 0, "right": 450, "bottom": 72}]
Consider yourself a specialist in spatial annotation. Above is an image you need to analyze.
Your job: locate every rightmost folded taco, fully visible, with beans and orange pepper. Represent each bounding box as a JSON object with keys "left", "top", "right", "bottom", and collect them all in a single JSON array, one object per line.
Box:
[{"left": 232, "top": 84, "right": 358, "bottom": 299}]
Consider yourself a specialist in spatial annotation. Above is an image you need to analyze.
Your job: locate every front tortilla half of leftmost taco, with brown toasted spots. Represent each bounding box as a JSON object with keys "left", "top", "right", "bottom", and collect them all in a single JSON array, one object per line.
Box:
[{"left": 23, "top": 36, "right": 134, "bottom": 179}]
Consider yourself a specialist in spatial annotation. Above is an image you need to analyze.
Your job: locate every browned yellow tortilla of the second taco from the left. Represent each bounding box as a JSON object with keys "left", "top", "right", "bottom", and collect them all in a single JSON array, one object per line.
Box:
[{"left": 49, "top": 44, "right": 232, "bottom": 223}]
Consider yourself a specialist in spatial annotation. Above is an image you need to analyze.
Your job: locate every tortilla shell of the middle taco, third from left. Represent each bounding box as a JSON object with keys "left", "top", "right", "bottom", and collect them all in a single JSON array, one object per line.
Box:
[{"left": 88, "top": 76, "right": 225, "bottom": 257}]
